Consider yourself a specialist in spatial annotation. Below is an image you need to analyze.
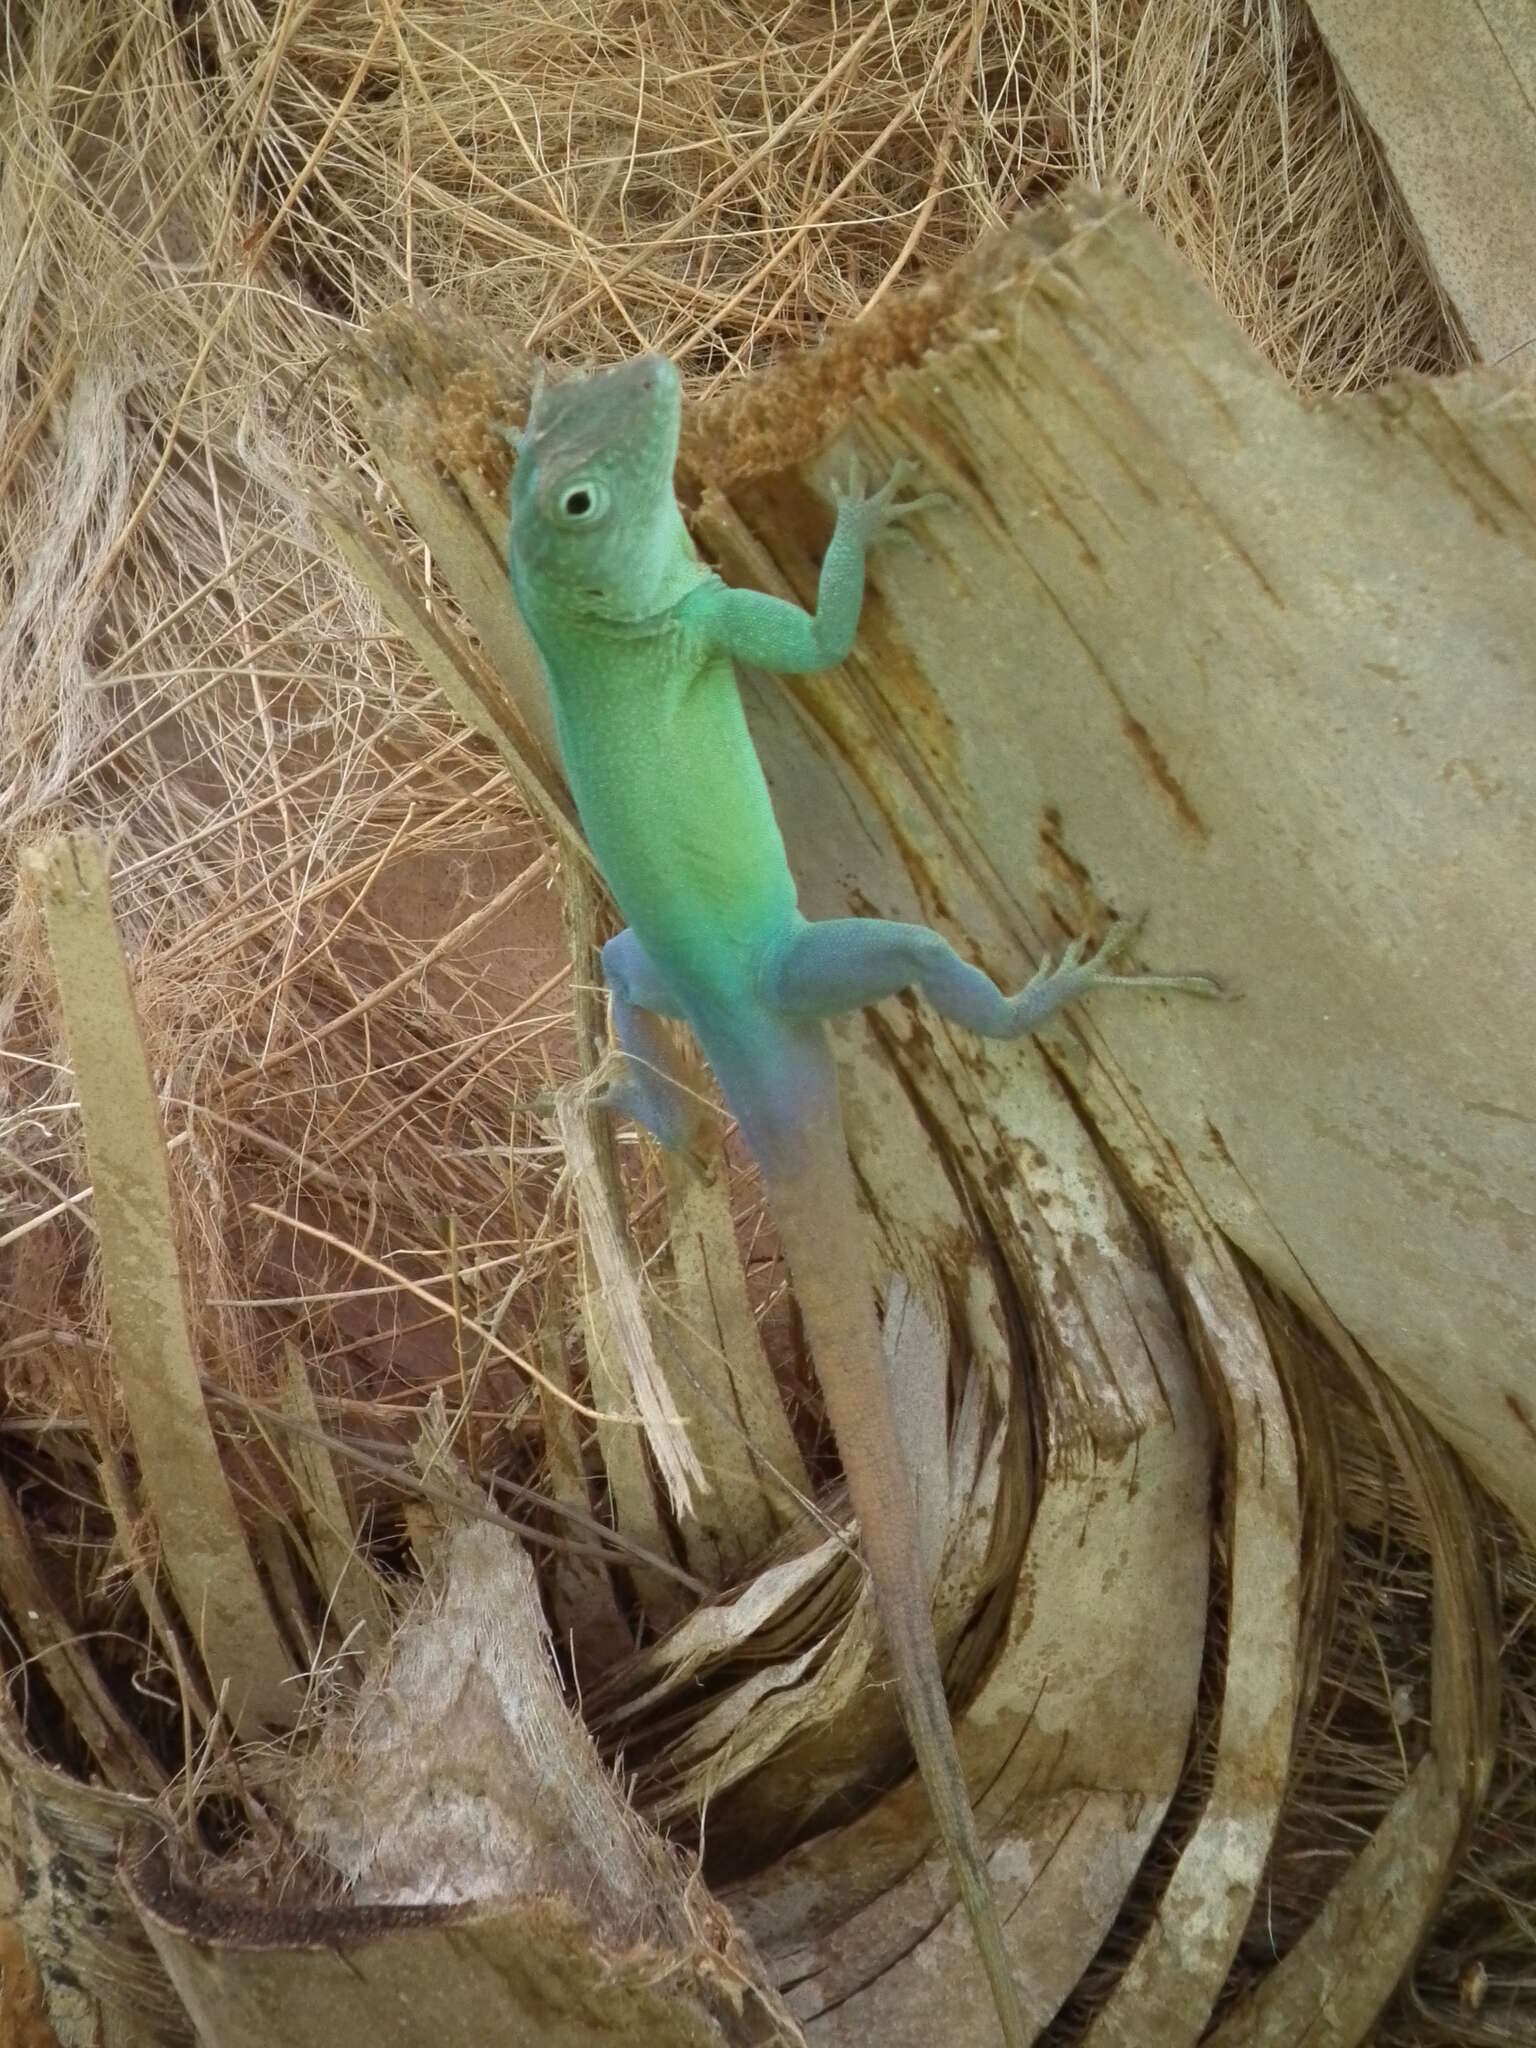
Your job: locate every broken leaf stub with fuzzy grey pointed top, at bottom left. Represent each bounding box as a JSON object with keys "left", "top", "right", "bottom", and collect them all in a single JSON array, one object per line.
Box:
[{"left": 140, "top": 1490, "right": 803, "bottom": 2048}]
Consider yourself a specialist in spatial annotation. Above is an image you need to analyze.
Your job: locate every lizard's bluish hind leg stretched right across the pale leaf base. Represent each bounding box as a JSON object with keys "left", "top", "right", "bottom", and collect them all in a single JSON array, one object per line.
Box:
[{"left": 760, "top": 918, "right": 1223, "bottom": 1038}]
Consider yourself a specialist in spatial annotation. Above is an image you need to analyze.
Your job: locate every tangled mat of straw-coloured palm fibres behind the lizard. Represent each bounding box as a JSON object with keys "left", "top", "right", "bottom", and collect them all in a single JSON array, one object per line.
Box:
[{"left": 0, "top": 0, "right": 1532, "bottom": 2040}]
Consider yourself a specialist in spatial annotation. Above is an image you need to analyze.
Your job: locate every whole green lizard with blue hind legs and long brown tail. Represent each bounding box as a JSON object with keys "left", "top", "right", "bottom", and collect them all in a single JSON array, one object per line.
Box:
[{"left": 508, "top": 356, "right": 1221, "bottom": 2048}]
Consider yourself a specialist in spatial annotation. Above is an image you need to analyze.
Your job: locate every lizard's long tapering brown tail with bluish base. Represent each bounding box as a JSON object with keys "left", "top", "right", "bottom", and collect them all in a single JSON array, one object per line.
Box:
[{"left": 705, "top": 1024, "right": 1032, "bottom": 2048}]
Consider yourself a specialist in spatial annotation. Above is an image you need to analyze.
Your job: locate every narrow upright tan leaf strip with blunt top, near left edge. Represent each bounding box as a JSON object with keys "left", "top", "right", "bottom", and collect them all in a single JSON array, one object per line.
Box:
[{"left": 25, "top": 834, "right": 299, "bottom": 1735}]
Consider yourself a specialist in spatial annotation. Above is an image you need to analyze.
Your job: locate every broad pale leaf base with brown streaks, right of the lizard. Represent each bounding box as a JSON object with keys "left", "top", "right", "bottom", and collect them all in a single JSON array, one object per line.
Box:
[{"left": 737, "top": 201, "right": 1536, "bottom": 1528}]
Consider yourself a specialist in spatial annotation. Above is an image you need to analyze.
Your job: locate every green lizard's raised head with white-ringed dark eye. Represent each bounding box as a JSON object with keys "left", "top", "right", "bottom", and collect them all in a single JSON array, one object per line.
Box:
[{"left": 508, "top": 356, "right": 692, "bottom": 618}]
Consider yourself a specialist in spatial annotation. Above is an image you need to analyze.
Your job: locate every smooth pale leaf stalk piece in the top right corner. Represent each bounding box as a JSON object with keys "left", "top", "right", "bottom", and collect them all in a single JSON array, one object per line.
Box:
[{"left": 1311, "top": 0, "right": 1536, "bottom": 375}]
